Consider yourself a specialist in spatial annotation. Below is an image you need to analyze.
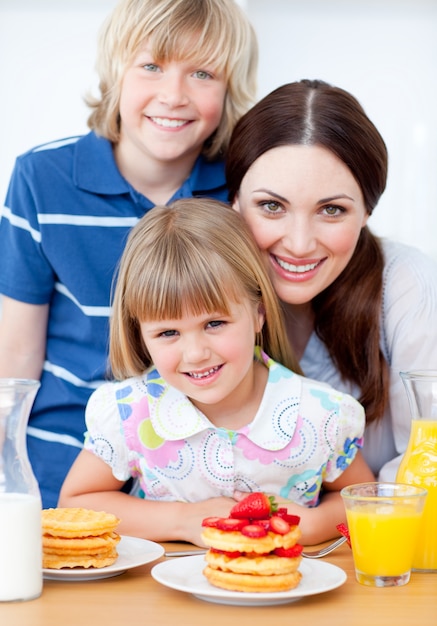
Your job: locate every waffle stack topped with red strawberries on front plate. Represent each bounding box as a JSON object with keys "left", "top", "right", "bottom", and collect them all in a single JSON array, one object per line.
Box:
[{"left": 202, "top": 492, "right": 302, "bottom": 593}]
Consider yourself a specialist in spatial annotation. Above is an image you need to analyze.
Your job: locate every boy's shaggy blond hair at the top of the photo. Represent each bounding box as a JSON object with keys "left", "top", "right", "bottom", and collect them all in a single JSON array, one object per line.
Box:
[{"left": 86, "top": 0, "right": 258, "bottom": 160}]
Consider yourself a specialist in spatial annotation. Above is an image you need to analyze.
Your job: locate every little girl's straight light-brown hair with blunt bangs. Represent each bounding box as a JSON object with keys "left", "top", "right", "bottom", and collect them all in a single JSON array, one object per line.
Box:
[{"left": 110, "top": 198, "right": 301, "bottom": 379}]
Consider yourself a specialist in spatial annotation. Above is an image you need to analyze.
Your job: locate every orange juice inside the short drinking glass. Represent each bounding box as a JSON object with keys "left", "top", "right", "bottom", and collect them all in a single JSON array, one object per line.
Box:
[{"left": 346, "top": 503, "right": 422, "bottom": 576}]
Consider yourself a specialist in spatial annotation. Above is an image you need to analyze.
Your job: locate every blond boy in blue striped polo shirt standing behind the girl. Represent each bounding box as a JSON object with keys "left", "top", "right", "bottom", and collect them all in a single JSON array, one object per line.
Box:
[{"left": 0, "top": 0, "right": 257, "bottom": 507}]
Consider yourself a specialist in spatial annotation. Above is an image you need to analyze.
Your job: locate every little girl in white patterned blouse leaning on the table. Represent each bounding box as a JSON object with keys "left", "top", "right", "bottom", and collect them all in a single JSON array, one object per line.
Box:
[{"left": 60, "top": 199, "right": 372, "bottom": 544}]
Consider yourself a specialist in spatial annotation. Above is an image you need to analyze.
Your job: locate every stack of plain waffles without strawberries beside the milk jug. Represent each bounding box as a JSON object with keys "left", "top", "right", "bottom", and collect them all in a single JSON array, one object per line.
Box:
[{"left": 42, "top": 508, "right": 120, "bottom": 569}]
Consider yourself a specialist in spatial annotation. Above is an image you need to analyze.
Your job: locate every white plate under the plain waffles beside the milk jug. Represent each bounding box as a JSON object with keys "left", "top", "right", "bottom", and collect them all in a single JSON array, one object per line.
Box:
[{"left": 43, "top": 536, "right": 164, "bottom": 582}]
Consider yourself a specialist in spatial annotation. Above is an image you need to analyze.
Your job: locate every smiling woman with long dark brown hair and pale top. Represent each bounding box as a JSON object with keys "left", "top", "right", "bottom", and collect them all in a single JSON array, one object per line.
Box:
[{"left": 226, "top": 80, "right": 437, "bottom": 480}]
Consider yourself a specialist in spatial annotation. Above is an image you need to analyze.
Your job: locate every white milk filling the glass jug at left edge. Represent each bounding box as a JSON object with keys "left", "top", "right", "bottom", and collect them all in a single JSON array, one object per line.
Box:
[{"left": 0, "top": 493, "right": 42, "bottom": 602}]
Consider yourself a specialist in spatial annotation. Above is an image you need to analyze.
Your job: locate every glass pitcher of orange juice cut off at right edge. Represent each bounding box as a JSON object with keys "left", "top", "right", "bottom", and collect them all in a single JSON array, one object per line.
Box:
[{"left": 396, "top": 370, "right": 437, "bottom": 571}]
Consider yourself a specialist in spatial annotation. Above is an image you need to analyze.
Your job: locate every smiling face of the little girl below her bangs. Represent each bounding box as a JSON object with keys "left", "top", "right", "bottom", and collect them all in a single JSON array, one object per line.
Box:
[{"left": 140, "top": 300, "right": 264, "bottom": 424}]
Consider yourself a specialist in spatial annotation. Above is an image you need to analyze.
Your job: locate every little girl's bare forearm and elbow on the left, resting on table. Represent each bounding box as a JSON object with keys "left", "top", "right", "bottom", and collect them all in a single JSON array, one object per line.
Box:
[{"left": 58, "top": 450, "right": 235, "bottom": 546}]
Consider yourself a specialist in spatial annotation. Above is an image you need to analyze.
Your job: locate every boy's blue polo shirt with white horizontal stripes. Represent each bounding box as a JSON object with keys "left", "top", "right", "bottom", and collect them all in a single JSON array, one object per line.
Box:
[{"left": 0, "top": 132, "right": 227, "bottom": 507}]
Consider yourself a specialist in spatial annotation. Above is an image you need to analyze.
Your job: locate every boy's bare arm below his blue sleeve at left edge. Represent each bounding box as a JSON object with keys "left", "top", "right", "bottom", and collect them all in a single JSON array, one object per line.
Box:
[{"left": 0, "top": 296, "right": 49, "bottom": 380}]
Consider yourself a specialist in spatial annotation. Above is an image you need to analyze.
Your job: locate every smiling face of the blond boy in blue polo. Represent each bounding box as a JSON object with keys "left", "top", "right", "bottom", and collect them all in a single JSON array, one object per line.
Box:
[{"left": 116, "top": 46, "right": 226, "bottom": 175}]
